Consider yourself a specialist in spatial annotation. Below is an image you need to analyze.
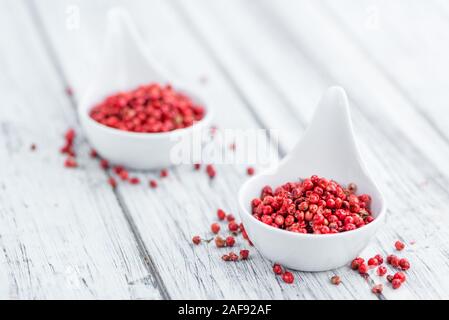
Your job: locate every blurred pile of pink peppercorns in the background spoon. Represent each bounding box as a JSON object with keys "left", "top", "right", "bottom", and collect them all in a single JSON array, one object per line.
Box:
[{"left": 90, "top": 83, "right": 205, "bottom": 133}]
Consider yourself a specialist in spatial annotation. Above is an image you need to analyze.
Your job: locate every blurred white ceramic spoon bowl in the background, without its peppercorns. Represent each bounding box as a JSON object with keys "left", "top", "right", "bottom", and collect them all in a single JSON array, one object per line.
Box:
[{"left": 78, "top": 8, "right": 212, "bottom": 169}]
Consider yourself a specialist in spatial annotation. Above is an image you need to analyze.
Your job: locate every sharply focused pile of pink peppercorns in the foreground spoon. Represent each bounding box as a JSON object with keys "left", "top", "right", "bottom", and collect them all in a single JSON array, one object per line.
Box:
[{"left": 251, "top": 175, "right": 374, "bottom": 234}]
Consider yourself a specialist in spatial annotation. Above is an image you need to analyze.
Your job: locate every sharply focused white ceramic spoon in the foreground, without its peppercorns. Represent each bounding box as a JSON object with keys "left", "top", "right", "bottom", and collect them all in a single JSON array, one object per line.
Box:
[{"left": 239, "top": 87, "right": 386, "bottom": 271}]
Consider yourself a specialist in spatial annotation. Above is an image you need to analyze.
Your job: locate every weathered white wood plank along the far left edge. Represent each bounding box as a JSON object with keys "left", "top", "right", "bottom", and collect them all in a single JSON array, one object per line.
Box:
[{"left": 0, "top": 1, "right": 161, "bottom": 299}]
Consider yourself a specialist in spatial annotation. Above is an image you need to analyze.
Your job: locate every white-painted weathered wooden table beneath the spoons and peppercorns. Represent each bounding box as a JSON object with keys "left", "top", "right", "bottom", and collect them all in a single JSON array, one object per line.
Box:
[{"left": 0, "top": 0, "right": 449, "bottom": 299}]
